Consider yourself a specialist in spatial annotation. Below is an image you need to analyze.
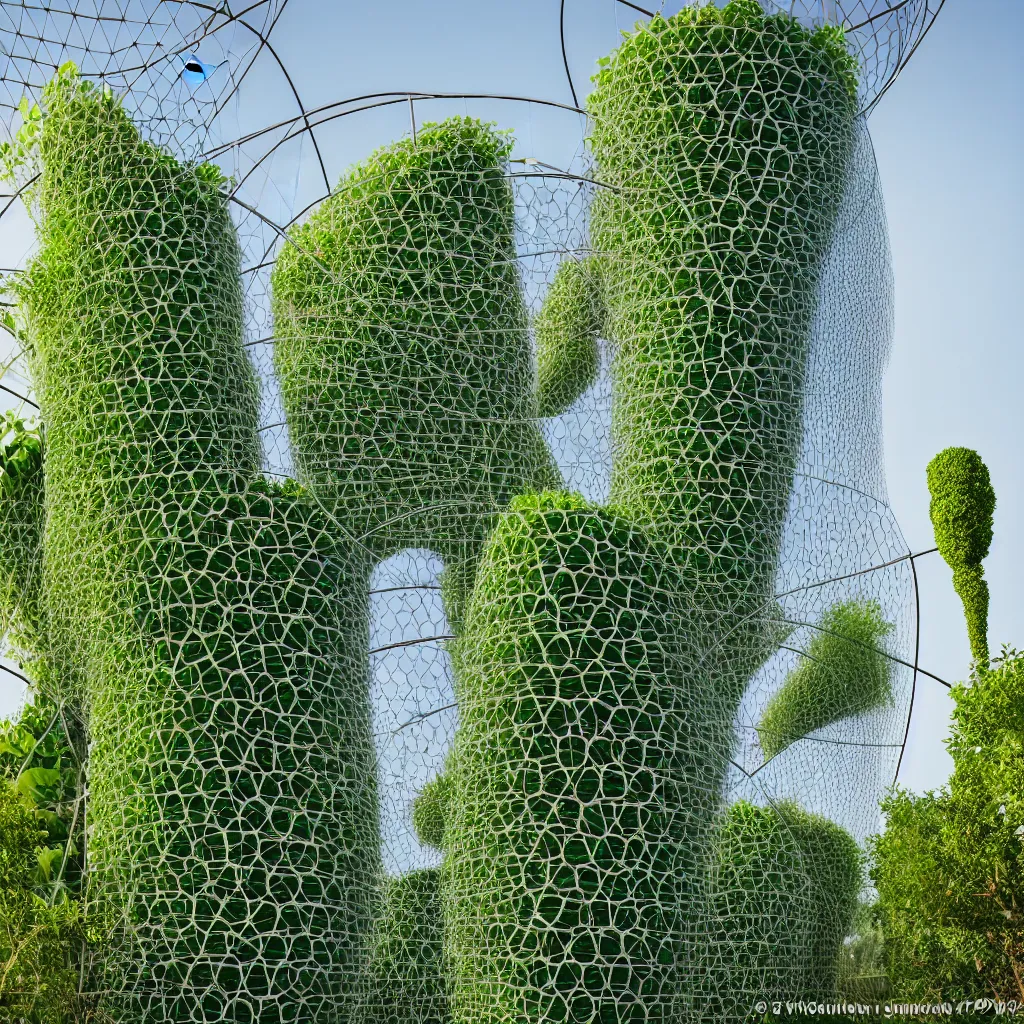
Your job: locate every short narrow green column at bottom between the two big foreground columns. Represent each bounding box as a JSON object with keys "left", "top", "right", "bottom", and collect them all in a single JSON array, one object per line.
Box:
[{"left": 364, "top": 867, "right": 452, "bottom": 1024}]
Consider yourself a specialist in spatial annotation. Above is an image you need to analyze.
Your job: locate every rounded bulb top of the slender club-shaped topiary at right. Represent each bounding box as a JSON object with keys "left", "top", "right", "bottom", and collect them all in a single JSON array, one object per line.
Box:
[{"left": 928, "top": 447, "right": 995, "bottom": 569}]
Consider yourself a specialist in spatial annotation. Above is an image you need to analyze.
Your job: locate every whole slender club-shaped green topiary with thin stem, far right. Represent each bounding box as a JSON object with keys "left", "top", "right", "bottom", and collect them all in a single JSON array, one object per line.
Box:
[{"left": 928, "top": 447, "right": 995, "bottom": 667}]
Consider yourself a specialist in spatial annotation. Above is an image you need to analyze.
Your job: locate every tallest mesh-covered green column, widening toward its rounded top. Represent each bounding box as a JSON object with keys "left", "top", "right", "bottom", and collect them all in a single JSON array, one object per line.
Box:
[{"left": 588, "top": 0, "right": 857, "bottom": 690}]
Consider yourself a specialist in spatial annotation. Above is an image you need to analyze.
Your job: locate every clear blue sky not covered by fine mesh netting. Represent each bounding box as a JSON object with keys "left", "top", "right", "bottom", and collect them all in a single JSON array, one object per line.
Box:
[{"left": 0, "top": 0, "right": 1011, "bottom": 806}]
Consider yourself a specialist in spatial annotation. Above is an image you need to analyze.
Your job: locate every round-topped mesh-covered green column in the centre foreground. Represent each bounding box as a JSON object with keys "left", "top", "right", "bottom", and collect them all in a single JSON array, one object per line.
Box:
[{"left": 443, "top": 494, "right": 730, "bottom": 1024}]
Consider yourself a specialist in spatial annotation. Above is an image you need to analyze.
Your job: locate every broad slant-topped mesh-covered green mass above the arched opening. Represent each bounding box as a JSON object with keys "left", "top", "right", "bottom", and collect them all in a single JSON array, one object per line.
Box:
[{"left": 272, "top": 118, "right": 557, "bottom": 618}]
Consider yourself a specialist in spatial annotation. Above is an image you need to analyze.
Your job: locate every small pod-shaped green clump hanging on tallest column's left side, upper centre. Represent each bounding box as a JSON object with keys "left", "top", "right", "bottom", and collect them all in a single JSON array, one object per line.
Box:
[{"left": 534, "top": 257, "right": 604, "bottom": 416}]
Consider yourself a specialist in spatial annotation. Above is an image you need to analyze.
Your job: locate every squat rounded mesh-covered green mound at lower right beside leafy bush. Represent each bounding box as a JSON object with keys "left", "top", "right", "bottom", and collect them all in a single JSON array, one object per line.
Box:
[{"left": 700, "top": 801, "right": 863, "bottom": 1020}]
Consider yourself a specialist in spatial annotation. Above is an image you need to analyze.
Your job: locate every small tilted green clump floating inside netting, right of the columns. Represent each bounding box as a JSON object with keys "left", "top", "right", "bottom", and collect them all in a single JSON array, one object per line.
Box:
[{"left": 758, "top": 599, "right": 893, "bottom": 758}]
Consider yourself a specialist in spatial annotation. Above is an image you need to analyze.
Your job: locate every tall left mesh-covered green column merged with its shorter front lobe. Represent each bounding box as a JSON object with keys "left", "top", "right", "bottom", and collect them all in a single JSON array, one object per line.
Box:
[{"left": 11, "top": 69, "right": 378, "bottom": 1024}]
